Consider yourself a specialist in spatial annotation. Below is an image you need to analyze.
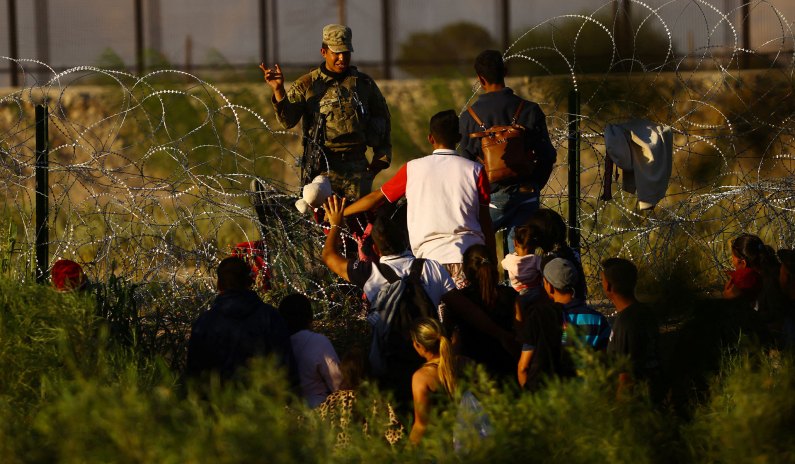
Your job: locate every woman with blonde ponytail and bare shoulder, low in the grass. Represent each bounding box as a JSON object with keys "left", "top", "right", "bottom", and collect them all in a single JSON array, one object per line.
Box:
[{"left": 409, "top": 317, "right": 456, "bottom": 445}]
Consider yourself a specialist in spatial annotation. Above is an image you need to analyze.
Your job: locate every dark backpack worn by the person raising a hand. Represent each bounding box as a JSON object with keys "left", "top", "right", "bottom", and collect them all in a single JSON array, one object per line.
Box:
[{"left": 367, "top": 258, "right": 438, "bottom": 377}]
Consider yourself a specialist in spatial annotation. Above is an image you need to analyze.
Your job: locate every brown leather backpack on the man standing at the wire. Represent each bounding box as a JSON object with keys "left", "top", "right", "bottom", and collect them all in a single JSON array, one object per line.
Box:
[{"left": 467, "top": 100, "right": 538, "bottom": 183}]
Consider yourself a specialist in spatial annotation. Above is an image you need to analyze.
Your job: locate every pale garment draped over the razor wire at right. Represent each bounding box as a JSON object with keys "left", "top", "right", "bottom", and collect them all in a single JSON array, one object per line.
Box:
[{"left": 605, "top": 119, "right": 673, "bottom": 210}]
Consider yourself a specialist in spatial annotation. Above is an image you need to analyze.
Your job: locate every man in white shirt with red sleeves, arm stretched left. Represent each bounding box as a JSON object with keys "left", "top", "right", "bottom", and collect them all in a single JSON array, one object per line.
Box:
[{"left": 345, "top": 110, "right": 496, "bottom": 288}]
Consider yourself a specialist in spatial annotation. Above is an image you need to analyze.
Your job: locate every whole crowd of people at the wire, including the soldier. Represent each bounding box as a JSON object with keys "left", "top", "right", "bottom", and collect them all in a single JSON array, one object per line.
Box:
[{"left": 168, "top": 25, "right": 795, "bottom": 443}]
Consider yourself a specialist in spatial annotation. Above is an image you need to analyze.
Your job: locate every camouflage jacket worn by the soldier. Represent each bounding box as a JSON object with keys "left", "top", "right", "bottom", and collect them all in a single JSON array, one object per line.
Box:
[{"left": 271, "top": 66, "right": 392, "bottom": 163}]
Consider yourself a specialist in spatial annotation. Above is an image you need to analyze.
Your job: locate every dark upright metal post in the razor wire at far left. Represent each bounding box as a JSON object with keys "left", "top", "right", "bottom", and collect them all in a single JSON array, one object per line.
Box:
[{"left": 36, "top": 105, "right": 50, "bottom": 283}]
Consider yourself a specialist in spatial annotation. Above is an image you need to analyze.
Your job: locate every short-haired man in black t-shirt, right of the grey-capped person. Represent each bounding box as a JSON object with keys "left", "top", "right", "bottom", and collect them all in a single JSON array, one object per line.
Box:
[{"left": 601, "top": 258, "right": 660, "bottom": 396}]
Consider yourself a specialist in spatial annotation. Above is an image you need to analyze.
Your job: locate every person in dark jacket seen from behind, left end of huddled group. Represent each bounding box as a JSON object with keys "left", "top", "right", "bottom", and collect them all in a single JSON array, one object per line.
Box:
[{"left": 186, "top": 257, "right": 297, "bottom": 383}]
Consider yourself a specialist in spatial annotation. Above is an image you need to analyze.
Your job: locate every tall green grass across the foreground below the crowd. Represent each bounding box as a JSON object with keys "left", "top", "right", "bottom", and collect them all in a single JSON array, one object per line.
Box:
[{"left": 0, "top": 279, "right": 795, "bottom": 463}]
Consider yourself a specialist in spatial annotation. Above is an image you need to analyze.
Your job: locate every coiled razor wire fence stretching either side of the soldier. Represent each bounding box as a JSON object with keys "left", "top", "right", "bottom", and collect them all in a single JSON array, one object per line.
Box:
[{"left": 0, "top": 0, "right": 795, "bottom": 312}]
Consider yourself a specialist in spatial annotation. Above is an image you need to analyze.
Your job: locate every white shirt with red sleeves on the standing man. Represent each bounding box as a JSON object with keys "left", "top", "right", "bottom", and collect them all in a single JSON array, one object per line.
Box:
[{"left": 381, "top": 150, "right": 490, "bottom": 264}]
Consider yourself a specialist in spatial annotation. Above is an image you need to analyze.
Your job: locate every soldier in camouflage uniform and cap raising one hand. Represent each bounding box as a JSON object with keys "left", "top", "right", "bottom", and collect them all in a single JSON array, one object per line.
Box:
[{"left": 261, "top": 24, "right": 392, "bottom": 200}]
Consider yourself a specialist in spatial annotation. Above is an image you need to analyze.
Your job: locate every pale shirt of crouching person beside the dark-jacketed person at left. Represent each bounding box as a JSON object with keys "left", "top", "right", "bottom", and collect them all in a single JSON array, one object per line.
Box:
[{"left": 290, "top": 330, "right": 342, "bottom": 408}]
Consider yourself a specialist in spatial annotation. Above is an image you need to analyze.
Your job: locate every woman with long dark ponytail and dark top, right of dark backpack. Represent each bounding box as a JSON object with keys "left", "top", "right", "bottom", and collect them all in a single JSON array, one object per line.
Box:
[{"left": 454, "top": 245, "right": 519, "bottom": 379}]
